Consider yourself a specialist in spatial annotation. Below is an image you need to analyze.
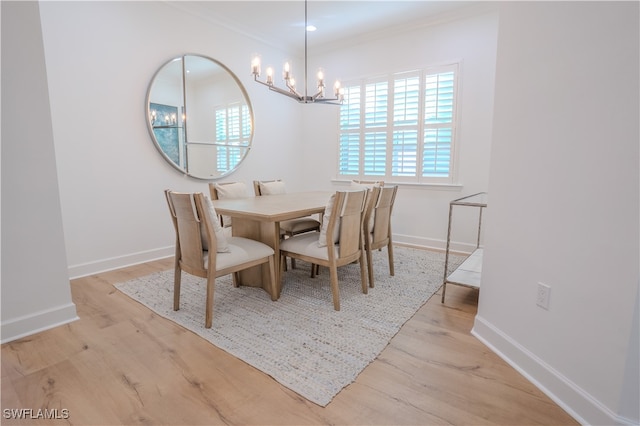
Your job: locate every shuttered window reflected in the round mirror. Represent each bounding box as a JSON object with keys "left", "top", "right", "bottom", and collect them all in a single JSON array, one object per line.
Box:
[{"left": 216, "top": 104, "right": 251, "bottom": 170}]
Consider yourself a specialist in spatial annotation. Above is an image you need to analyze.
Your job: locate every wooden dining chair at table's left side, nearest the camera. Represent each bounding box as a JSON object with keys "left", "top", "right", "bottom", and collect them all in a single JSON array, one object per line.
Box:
[{"left": 165, "top": 190, "right": 277, "bottom": 328}]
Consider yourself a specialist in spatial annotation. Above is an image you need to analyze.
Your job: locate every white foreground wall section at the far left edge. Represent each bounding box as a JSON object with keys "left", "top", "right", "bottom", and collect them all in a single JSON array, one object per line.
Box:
[{"left": 0, "top": 2, "right": 77, "bottom": 342}]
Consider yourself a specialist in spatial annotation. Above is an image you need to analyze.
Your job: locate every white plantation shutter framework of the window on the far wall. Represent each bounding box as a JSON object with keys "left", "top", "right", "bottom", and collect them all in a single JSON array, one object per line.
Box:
[{"left": 336, "top": 62, "right": 461, "bottom": 186}]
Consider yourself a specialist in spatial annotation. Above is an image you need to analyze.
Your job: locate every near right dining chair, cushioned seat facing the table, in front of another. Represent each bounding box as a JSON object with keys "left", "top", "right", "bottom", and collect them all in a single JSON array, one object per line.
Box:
[{"left": 280, "top": 189, "right": 369, "bottom": 311}]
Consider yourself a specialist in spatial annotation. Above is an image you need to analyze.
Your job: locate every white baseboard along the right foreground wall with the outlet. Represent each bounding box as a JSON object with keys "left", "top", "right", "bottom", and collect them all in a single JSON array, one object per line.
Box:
[{"left": 471, "top": 316, "right": 634, "bottom": 426}]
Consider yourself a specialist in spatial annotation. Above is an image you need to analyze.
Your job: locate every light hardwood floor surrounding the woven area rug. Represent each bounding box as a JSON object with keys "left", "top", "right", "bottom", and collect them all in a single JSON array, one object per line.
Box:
[{"left": 0, "top": 255, "right": 577, "bottom": 425}]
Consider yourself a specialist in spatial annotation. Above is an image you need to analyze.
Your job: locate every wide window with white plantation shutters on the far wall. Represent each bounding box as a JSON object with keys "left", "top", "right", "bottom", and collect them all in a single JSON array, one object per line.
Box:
[{"left": 338, "top": 64, "right": 458, "bottom": 183}]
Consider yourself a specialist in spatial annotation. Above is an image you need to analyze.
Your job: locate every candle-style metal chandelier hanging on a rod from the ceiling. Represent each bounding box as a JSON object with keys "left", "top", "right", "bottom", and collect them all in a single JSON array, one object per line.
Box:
[{"left": 251, "top": 0, "right": 344, "bottom": 105}]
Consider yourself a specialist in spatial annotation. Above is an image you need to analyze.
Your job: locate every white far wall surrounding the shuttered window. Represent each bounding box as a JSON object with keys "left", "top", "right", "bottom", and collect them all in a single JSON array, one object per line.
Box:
[{"left": 301, "top": 4, "right": 498, "bottom": 251}]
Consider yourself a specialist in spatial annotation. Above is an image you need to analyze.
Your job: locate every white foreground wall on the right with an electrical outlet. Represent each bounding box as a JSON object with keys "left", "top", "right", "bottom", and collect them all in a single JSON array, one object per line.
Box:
[{"left": 474, "top": 2, "right": 640, "bottom": 424}]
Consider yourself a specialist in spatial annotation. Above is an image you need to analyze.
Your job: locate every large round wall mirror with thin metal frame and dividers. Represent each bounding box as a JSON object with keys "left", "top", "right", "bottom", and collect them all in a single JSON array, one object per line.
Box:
[{"left": 146, "top": 55, "right": 253, "bottom": 179}]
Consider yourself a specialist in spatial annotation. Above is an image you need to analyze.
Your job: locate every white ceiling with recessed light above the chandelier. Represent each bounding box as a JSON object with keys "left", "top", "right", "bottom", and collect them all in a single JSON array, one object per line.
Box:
[{"left": 167, "top": 0, "right": 477, "bottom": 54}]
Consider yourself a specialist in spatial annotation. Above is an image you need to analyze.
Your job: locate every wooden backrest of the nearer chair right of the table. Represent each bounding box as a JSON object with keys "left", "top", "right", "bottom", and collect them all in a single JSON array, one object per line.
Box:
[{"left": 327, "top": 189, "right": 369, "bottom": 258}]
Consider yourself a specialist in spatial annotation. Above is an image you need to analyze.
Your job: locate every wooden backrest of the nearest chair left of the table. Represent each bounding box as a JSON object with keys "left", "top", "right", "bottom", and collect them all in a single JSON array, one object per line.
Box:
[{"left": 165, "top": 190, "right": 216, "bottom": 276}]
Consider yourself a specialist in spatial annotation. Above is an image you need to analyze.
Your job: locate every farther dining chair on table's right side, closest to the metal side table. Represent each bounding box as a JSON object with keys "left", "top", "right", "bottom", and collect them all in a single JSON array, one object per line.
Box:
[{"left": 362, "top": 186, "right": 398, "bottom": 288}]
